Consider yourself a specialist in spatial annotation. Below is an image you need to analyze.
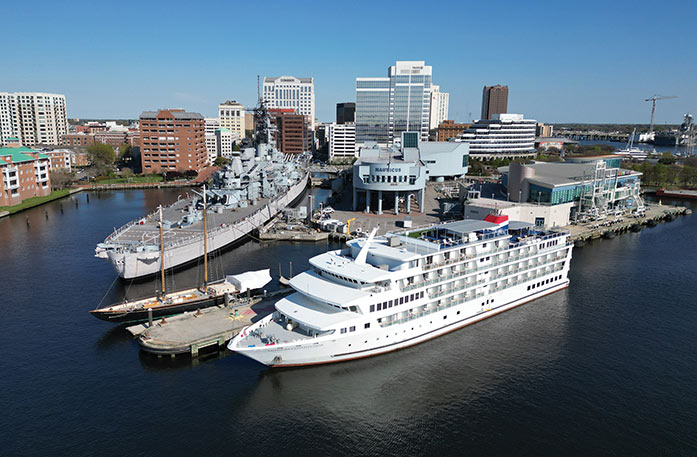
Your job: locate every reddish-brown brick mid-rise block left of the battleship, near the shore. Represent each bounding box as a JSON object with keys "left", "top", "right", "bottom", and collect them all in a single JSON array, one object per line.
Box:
[{"left": 140, "top": 109, "right": 207, "bottom": 173}]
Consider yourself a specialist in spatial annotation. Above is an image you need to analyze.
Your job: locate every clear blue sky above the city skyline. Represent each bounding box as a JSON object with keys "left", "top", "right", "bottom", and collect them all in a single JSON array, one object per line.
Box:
[{"left": 0, "top": 0, "right": 697, "bottom": 123}]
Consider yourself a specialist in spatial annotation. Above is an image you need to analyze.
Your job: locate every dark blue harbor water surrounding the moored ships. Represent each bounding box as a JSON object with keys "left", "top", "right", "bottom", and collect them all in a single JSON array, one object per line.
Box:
[{"left": 0, "top": 190, "right": 697, "bottom": 456}]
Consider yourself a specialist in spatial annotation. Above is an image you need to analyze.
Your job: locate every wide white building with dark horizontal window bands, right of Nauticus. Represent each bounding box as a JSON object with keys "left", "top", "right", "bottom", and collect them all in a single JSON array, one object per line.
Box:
[{"left": 456, "top": 114, "right": 537, "bottom": 158}]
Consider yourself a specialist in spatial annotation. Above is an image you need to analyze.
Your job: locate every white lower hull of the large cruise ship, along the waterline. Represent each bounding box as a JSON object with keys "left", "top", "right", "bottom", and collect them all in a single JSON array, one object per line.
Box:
[{"left": 229, "top": 267, "right": 569, "bottom": 367}]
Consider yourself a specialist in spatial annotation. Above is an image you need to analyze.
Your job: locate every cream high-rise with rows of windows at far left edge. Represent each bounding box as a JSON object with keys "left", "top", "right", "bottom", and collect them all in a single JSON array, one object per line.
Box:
[{"left": 0, "top": 92, "right": 68, "bottom": 146}]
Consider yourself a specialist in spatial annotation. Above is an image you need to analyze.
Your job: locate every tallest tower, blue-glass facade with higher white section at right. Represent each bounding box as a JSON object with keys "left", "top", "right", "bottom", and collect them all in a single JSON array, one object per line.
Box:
[{"left": 356, "top": 61, "right": 432, "bottom": 145}]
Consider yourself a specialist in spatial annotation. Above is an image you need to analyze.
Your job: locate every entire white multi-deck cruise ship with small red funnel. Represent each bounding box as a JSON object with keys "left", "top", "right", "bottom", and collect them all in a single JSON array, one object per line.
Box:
[{"left": 228, "top": 215, "right": 573, "bottom": 367}]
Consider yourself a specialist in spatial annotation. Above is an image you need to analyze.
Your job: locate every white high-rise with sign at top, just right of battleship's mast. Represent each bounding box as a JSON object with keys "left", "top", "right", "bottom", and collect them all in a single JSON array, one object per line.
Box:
[{"left": 260, "top": 76, "right": 315, "bottom": 127}]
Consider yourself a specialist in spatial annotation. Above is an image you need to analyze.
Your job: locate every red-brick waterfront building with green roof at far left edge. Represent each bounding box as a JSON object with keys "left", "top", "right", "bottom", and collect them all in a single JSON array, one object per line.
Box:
[{"left": 0, "top": 143, "right": 51, "bottom": 206}]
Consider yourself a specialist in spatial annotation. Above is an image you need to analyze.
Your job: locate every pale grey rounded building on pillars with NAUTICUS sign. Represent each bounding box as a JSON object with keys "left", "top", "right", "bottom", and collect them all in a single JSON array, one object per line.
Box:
[{"left": 353, "top": 132, "right": 469, "bottom": 214}]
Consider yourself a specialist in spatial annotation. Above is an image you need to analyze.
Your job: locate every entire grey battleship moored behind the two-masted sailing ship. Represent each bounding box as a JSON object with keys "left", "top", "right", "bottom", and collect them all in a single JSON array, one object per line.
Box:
[{"left": 95, "top": 104, "right": 309, "bottom": 279}]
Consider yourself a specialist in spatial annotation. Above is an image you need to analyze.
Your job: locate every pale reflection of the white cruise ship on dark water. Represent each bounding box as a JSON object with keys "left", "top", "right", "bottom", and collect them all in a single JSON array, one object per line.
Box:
[{"left": 238, "top": 290, "right": 569, "bottom": 427}]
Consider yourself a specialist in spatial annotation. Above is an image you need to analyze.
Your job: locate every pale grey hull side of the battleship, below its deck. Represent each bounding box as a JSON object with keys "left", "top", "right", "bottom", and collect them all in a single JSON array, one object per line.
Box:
[{"left": 101, "top": 176, "right": 308, "bottom": 279}]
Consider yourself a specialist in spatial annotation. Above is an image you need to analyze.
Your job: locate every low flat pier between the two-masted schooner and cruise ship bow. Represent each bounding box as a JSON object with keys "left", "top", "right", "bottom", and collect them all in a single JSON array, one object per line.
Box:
[{"left": 127, "top": 290, "right": 290, "bottom": 357}]
